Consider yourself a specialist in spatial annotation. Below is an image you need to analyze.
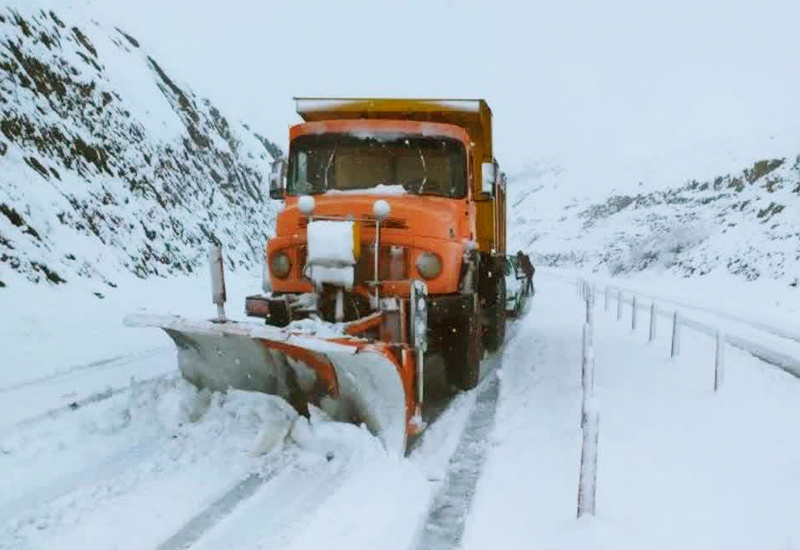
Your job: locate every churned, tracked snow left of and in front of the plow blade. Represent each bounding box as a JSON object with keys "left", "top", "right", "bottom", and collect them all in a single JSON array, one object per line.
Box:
[{"left": 0, "top": 273, "right": 470, "bottom": 550}]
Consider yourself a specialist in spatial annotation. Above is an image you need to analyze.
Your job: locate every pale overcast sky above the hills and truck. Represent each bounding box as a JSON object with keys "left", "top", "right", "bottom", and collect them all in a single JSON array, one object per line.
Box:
[{"left": 79, "top": 0, "right": 800, "bottom": 170}]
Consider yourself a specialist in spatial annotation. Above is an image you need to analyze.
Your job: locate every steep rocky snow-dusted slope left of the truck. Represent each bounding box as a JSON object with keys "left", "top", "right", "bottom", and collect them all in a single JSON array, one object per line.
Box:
[{"left": 0, "top": 2, "right": 280, "bottom": 287}]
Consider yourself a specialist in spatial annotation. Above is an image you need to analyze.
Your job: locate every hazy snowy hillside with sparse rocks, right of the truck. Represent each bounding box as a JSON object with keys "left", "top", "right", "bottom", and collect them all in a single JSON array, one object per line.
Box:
[{"left": 509, "top": 141, "right": 800, "bottom": 286}]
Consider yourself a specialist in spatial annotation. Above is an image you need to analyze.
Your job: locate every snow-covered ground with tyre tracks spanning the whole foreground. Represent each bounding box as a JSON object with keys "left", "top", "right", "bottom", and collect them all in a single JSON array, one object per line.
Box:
[{"left": 0, "top": 277, "right": 800, "bottom": 550}]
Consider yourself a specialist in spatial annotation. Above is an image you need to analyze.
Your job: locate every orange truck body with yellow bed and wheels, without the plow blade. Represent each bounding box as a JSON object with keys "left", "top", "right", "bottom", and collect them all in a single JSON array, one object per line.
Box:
[{"left": 247, "top": 98, "right": 506, "bottom": 389}]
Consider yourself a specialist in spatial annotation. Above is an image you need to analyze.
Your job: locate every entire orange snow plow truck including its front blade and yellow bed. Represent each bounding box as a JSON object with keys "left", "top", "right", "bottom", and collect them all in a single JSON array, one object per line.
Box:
[{"left": 126, "top": 98, "right": 506, "bottom": 453}]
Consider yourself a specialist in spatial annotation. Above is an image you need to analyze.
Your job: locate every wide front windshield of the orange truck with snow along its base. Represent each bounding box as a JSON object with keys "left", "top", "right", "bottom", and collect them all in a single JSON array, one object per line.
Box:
[{"left": 287, "top": 134, "right": 467, "bottom": 198}]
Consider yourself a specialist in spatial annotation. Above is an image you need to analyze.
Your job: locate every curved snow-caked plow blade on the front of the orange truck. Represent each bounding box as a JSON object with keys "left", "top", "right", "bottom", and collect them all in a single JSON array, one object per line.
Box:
[{"left": 124, "top": 314, "right": 408, "bottom": 455}]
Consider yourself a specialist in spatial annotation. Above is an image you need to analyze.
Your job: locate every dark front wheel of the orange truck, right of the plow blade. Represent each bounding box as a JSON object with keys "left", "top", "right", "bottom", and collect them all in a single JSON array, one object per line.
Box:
[{"left": 444, "top": 304, "right": 483, "bottom": 390}]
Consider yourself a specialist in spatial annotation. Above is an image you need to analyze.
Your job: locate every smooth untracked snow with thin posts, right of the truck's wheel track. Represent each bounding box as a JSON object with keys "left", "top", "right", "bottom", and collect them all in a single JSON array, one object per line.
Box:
[{"left": 463, "top": 278, "right": 800, "bottom": 549}]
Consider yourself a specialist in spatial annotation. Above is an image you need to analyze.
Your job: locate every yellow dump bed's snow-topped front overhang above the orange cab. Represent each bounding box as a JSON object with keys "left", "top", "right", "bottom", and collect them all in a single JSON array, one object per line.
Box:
[{"left": 294, "top": 97, "right": 492, "bottom": 162}]
